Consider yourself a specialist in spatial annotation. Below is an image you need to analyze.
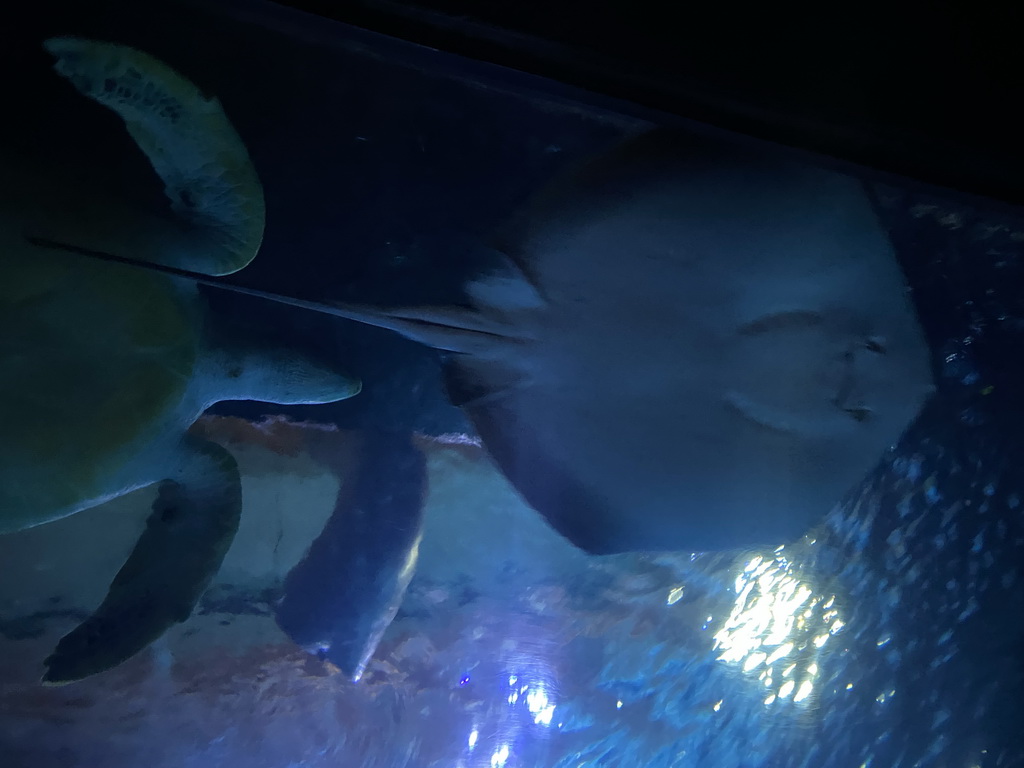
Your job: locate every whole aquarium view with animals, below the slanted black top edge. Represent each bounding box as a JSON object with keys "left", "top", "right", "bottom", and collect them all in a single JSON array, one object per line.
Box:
[{"left": 0, "top": 0, "right": 1024, "bottom": 768}]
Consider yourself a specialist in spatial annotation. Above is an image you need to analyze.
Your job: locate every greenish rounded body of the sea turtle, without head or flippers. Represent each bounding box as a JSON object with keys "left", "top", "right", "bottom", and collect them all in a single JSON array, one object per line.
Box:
[{"left": 0, "top": 238, "right": 201, "bottom": 530}]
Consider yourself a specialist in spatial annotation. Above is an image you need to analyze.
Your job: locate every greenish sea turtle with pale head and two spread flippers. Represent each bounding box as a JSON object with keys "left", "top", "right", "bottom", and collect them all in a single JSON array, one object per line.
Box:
[{"left": 0, "top": 38, "right": 359, "bottom": 684}]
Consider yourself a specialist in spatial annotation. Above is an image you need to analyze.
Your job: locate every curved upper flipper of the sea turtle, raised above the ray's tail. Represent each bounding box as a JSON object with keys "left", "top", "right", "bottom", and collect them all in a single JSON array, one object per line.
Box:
[{"left": 29, "top": 37, "right": 265, "bottom": 274}]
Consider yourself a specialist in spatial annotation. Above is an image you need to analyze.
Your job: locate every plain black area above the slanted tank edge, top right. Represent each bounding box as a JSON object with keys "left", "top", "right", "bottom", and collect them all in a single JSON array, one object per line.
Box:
[{"left": 272, "top": 0, "right": 1024, "bottom": 204}]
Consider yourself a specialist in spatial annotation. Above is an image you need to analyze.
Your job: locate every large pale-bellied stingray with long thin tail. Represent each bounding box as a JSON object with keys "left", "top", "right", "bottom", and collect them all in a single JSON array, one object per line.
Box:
[{"left": 32, "top": 130, "right": 934, "bottom": 553}]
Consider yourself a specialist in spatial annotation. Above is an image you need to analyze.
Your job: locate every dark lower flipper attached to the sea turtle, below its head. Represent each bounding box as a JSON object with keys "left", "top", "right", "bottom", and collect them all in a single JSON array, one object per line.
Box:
[{"left": 43, "top": 436, "right": 242, "bottom": 685}]
